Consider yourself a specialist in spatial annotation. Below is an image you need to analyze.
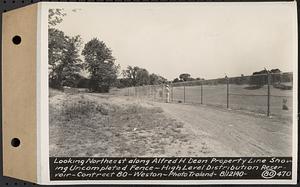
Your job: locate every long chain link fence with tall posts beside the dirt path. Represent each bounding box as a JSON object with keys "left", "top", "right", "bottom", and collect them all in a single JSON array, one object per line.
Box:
[{"left": 119, "top": 73, "right": 293, "bottom": 117}]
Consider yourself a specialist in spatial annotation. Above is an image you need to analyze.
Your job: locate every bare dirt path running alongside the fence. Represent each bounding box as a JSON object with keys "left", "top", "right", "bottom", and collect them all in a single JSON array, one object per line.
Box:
[{"left": 154, "top": 103, "right": 292, "bottom": 156}]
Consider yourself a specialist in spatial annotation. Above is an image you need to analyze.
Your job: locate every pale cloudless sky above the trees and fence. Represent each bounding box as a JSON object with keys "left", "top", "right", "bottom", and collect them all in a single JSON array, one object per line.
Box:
[{"left": 50, "top": 2, "right": 297, "bottom": 80}]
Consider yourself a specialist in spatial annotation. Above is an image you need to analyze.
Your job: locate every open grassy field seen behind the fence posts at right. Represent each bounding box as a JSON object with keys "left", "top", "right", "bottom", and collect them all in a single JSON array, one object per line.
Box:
[{"left": 174, "top": 85, "right": 293, "bottom": 117}]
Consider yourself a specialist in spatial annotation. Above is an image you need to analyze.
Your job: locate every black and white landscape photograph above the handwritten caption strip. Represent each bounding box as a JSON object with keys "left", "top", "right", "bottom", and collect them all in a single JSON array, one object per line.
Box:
[{"left": 47, "top": 3, "right": 298, "bottom": 183}]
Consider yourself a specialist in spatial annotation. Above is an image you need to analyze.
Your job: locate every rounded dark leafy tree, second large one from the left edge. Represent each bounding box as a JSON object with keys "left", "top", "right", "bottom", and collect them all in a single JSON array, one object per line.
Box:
[{"left": 82, "top": 38, "right": 119, "bottom": 92}]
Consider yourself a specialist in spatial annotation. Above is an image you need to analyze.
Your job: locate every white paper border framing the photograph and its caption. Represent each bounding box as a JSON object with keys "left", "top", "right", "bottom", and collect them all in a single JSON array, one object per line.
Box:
[{"left": 37, "top": 1, "right": 298, "bottom": 185}]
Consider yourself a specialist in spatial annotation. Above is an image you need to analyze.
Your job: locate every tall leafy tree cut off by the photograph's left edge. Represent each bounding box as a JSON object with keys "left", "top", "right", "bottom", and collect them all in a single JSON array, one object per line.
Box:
[{"left": 48, "top": 9, "right": 82, "bottom": 89}]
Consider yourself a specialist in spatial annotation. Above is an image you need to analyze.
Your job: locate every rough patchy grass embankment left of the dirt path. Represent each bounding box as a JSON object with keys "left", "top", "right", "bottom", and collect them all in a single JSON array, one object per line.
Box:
[{"left": 49, "top": 90, "right": 188, "bottom": 157}]
